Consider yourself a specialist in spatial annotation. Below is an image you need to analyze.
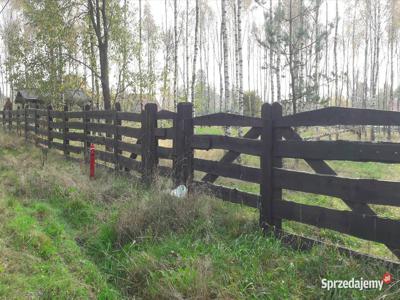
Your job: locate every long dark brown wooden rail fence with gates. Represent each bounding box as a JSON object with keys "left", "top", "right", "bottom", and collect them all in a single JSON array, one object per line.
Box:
[{"left": 2, "top": 103, "right": 400, "bottom": 257}]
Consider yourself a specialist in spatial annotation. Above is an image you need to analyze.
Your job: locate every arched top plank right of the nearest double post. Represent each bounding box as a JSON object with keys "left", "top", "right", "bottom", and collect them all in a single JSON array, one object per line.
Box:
[{"left": 275, "top": 107, "right": 400, "bottom": 127}]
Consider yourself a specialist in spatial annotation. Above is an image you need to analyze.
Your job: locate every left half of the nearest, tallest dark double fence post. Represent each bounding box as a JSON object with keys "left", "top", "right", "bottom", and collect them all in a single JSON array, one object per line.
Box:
[{"left": 260, "top": 103, "right": 274, "bottom": 231}]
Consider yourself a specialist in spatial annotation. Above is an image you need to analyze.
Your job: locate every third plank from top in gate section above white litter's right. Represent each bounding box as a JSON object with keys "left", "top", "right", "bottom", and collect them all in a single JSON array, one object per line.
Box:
[{"left": 193, "top": 158, "right": 261, "bottom": 183}]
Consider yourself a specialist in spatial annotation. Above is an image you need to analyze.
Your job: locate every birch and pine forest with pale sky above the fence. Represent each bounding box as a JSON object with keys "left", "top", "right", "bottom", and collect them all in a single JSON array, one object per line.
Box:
[{"left": 0, "top": 0, "right": 400, "bottom": 116}]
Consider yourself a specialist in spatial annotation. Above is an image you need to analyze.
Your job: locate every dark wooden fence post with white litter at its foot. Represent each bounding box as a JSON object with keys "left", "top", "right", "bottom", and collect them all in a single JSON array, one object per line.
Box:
[{"left": 173, "top": 102, "right": 193, "bottom": 186}]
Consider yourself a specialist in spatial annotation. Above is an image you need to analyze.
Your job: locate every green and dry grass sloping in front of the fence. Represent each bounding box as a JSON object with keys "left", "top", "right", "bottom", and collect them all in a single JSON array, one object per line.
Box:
[{"left": 0, "top": 129, "right": 400, "bottom": 299}]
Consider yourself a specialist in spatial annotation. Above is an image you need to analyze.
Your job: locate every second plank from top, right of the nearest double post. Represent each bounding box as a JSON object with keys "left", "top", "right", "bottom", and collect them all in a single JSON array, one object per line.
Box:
[{"left": 274, "top": 141, "right": 400, "bottom": 163}]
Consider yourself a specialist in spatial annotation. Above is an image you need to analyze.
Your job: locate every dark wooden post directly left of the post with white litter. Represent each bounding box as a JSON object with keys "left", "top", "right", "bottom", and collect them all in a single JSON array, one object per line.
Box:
[{"left": 142, "top": 103, "right": 158, "bottom": 184}]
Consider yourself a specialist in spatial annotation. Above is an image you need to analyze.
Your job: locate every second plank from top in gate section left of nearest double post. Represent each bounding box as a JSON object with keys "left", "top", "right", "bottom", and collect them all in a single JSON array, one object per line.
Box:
[{"left": 192, "top": 134, "right": 262, "bottom": 156}]
